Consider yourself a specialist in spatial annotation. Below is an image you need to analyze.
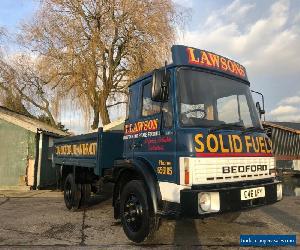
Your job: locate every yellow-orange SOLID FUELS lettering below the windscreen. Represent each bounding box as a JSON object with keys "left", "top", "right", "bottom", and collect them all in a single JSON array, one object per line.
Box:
[{"left": 194, "top": 133, "right": 272, "bottom": 155}]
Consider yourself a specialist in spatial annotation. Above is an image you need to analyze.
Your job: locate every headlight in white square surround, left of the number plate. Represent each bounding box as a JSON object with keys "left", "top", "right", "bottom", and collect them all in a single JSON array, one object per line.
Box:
[{"left": 198, "top": 192, "right": 220, "bottom": 214}]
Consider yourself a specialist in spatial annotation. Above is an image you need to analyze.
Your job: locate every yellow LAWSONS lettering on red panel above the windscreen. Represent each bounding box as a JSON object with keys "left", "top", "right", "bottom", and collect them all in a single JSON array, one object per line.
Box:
[{"left": 186, "top": 48, "right": 247, "bottom": 79}]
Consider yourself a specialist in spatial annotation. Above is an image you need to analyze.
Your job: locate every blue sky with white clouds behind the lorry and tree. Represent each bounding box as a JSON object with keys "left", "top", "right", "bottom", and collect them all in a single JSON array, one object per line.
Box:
[{"left": 0, "top": 0, "right": 300, "bottom": 133}]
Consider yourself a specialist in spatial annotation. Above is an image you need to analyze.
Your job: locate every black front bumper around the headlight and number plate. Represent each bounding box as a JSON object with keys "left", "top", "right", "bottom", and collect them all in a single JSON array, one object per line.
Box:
[{"left": 180, "top": 180, "right": 281, "bottom": 218}]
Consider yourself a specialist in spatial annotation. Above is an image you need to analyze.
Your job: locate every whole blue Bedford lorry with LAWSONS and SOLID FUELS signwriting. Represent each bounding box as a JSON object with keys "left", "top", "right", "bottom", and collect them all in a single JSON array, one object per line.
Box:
[{"left": 53, "top": 45, "right": 282, "bottom": 242}]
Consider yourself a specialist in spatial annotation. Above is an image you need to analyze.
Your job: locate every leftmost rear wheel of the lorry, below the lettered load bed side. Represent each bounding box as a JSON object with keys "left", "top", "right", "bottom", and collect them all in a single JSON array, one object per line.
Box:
[{"left": 64, "top": 174, "right": 81, "bottom": 211}]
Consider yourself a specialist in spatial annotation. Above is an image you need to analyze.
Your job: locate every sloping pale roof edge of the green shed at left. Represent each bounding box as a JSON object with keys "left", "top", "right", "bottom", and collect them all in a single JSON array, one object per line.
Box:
[{"left": 0, "top": 106, "right": 69, "bottom": 136}]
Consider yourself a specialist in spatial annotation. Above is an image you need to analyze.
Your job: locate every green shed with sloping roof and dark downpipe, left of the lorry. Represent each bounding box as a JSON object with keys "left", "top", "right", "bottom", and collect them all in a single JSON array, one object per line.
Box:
[{"left": 0, "top": 106, "right": 68, "bottom": 189}]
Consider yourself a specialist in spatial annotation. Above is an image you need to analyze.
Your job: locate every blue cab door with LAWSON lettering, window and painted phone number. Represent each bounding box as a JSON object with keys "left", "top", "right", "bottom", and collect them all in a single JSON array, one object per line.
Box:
[{"left": 133, "top": 79, "right": 176, "bottom": 183}]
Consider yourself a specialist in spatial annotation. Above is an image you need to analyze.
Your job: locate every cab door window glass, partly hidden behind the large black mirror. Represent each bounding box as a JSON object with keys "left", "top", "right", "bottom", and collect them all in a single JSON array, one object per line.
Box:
[{"left": 142, "top": 82, "right": 173, "bottom": 128}]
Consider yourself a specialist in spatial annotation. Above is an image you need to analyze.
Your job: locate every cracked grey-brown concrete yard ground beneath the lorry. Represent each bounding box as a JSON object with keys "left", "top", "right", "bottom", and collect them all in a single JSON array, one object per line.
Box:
[{"left": 0, "top": 181, "right": 300, "bottom": 249}]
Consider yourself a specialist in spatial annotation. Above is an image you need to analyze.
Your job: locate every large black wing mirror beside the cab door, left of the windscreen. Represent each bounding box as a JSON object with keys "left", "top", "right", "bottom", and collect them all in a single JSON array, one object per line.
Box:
[{"left": 151, "top": 69, "right": 170, "bottom": 102}]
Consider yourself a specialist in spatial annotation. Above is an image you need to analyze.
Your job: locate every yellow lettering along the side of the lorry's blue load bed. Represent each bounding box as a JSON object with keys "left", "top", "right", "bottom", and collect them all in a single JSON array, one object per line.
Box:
[{"left": 55, "top": 142, "right": 97, "bottom": 156}]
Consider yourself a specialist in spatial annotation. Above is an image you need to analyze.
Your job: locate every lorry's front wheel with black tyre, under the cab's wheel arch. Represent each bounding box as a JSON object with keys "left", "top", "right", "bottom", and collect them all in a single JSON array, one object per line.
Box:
[{"left": 120, "top": 180, "right": 155, "bottom": 243}]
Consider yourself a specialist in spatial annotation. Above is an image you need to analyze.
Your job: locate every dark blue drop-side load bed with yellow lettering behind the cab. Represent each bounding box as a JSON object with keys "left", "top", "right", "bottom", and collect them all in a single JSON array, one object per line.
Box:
[{"left": 53, "top": 129, "right": 123, "bottom": 176}]
